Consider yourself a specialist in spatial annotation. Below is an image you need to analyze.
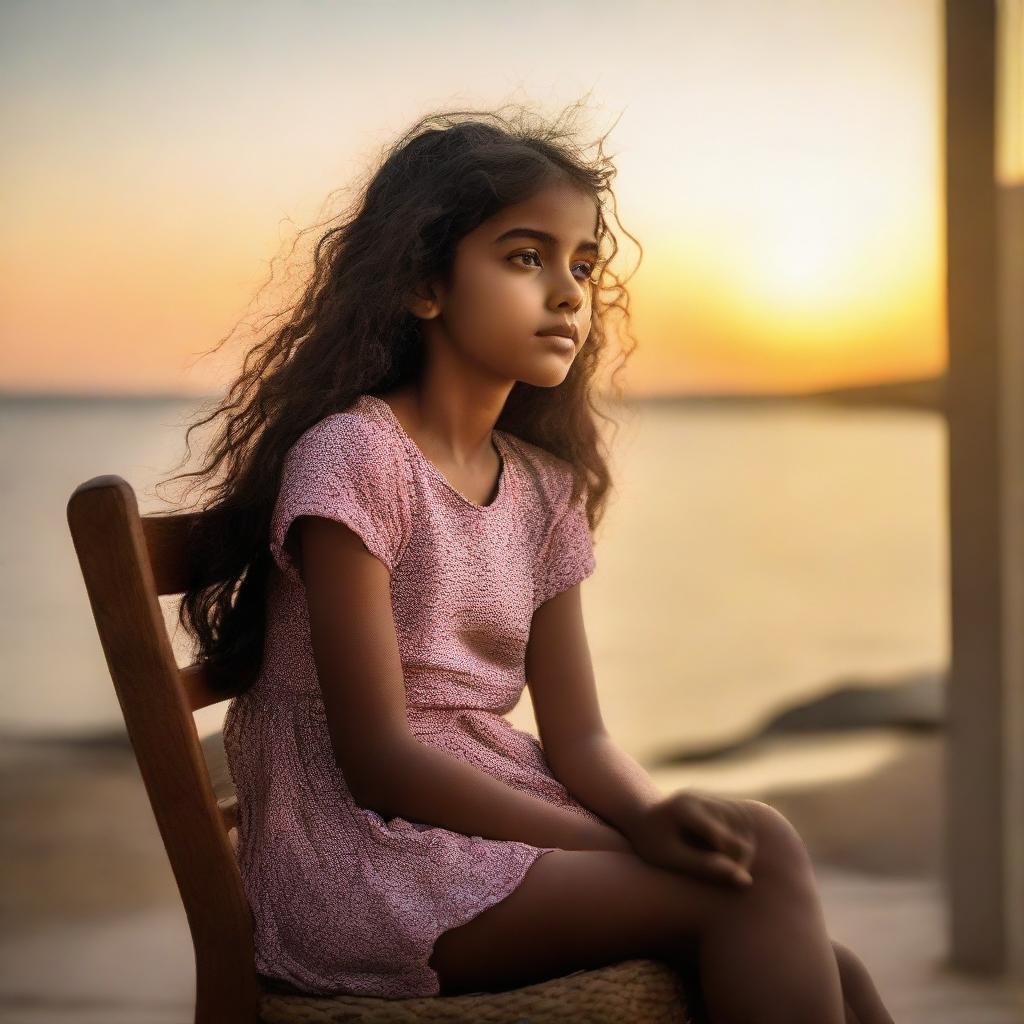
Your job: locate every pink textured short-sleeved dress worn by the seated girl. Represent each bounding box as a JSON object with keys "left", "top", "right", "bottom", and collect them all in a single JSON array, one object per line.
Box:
[{"left": 223, "top": 394, "right": 601, "bottom": 998}]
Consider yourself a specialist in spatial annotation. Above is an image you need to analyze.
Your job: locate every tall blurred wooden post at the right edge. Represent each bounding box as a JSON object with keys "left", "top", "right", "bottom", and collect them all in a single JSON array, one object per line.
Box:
[{"left": 945, "top": 0, "right": 1024, "bottom": 978}]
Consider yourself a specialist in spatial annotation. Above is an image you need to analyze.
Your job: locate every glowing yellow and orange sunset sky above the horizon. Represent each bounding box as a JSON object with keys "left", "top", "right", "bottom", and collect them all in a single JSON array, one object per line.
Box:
[{"left": 0, "top": 0, "right": 1011, "bottom": 392}]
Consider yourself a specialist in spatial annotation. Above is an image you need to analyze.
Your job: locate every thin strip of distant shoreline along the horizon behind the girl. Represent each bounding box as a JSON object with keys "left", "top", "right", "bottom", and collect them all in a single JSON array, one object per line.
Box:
[{"left": 0, "top": 374, "right": 946, "bottom": 413}]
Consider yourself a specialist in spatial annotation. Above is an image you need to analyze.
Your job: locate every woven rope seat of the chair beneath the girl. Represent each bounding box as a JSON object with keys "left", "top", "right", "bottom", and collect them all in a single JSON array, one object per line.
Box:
[{"left": 260, "top": 959, "right": 694, "bottom": 1024}]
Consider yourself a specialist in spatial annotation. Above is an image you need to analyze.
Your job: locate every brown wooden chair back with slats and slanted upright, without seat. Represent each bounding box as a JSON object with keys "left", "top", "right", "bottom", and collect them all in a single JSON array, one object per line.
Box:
[{"left": 68, "top": 475, "right": 259, "bottom": 1024}]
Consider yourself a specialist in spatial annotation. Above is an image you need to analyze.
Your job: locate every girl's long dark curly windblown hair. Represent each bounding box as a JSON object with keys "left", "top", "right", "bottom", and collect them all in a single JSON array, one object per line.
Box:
[{"left": 158, "top": 101, "right": 642, "bottom": 697}]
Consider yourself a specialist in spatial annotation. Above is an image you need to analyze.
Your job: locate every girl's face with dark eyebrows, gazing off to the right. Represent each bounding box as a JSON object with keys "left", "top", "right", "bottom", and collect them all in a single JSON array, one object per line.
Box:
[{"left": 413, "top": 184, "right": 598, "bottom": 387}]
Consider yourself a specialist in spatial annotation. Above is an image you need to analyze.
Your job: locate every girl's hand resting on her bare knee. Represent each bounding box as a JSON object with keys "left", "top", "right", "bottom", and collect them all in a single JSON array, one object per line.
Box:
[{"left": 626, "top": 790, "right": 755, "bottom": 887}]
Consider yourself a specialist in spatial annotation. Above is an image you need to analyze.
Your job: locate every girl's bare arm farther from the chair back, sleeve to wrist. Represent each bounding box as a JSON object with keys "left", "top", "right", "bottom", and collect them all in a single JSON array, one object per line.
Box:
[{"left": 526, "top": 584, "right": 663, "bottom": 836}]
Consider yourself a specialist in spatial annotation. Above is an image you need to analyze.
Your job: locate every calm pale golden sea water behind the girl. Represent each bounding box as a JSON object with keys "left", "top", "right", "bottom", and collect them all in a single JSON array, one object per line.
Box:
[{"left": 0, "top": 398, "right": 949, "bottom": 786}]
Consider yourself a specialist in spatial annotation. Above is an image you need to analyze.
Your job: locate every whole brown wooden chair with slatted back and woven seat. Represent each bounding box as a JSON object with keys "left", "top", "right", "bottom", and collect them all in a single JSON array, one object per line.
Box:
[{"left": 68, "top": 475, "right": 692, "bottom": 1024}]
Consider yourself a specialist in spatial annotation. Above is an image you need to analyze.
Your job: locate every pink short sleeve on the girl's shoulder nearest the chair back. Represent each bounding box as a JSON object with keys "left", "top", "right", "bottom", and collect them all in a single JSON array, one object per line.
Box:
[{"left": 270, "top": 413, "right": 411, "bottom": 580}]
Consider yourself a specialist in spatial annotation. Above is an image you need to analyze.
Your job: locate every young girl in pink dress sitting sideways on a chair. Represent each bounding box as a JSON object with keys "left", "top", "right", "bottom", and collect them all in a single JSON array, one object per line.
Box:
[{"left": 163, "top": 103, "right": 891, "bottom": 1024}]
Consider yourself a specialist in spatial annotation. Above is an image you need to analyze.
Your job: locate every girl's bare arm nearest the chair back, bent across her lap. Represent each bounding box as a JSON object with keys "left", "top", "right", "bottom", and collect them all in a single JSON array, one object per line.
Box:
[{"left": 296, "top": 516, "right": 631, "bottom": 851}]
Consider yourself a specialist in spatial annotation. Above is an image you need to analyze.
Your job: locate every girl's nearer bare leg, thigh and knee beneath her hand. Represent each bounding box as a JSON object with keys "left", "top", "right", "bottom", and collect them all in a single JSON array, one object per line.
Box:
[{"left": 430, "top": 801, "right": 847, "bottom": 1024}]
